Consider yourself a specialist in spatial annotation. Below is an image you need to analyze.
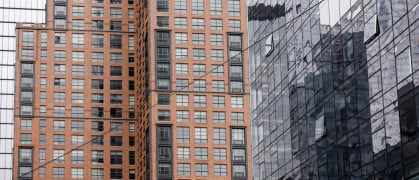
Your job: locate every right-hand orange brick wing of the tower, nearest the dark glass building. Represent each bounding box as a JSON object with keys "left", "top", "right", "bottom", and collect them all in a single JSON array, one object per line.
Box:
[{"left": 139, "top": 0, "right": 251, "bottom": 179}]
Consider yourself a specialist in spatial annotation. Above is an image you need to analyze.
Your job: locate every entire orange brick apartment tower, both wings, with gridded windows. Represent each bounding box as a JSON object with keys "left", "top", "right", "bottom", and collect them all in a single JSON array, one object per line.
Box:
[{"left": 14, "top": 0, "right": 252, "bottom": 180}]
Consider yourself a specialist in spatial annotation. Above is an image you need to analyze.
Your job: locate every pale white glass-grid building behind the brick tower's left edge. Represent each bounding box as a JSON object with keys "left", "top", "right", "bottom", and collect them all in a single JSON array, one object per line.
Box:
[{"left": 0, "top": 0, "right": 45, "bottom": 180}]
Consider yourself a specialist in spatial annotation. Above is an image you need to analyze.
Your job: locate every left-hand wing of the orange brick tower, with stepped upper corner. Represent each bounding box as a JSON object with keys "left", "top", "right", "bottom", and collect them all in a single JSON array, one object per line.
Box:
[{"left": 13, "top": 0, "right": 138, "bottom": 179}]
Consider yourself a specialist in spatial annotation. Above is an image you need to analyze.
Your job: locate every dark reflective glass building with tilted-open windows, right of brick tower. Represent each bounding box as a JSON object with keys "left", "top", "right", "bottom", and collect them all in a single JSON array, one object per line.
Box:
[{"left": 248, "top": 0, "right": 419, "bottom": 180}]
